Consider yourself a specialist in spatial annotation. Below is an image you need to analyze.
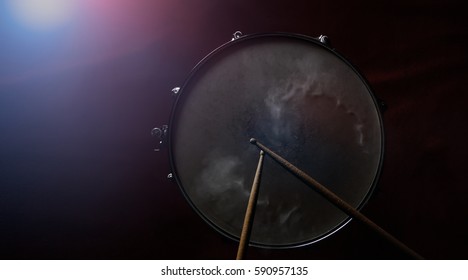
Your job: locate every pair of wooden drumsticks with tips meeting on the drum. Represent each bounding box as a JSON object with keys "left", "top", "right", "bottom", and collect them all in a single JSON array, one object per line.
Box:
[{"left": 237, "top": 138, "right": 423, "bottom": 260}]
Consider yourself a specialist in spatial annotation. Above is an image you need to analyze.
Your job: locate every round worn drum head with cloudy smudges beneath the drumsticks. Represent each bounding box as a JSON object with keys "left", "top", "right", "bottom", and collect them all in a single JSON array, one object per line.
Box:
[{"left": 169, "top": 34, "right": 383, "bottom": 248}]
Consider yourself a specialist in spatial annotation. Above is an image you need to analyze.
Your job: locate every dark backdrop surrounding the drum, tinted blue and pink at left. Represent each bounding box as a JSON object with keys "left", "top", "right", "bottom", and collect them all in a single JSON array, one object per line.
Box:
[{"left": 0, "top": 0, "right": 468, "bottom": 259}]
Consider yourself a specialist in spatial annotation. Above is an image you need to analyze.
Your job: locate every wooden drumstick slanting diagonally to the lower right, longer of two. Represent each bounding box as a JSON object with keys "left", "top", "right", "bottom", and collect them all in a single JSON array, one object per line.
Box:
[{"left": 250, "top": 138, "right": 424, "bottom": 259}]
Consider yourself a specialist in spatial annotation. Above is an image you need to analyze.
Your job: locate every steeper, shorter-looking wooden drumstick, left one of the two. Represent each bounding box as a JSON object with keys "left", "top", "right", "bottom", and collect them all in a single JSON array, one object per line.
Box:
[{"left": 236, "top": 150, "right": 264, "bottom": 260}]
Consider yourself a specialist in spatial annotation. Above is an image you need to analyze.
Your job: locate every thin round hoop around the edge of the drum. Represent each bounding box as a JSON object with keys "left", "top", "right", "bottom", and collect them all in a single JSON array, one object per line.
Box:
[{"left": 167, "top": 32, "right": 386, "bottom": 249}]
